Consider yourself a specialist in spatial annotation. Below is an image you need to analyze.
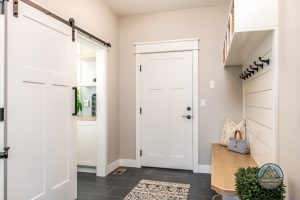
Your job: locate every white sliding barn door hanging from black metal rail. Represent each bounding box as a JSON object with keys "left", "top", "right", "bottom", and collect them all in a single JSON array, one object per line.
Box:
[{"left": 7, "top": 1, "right": 76, "bottom": 200}]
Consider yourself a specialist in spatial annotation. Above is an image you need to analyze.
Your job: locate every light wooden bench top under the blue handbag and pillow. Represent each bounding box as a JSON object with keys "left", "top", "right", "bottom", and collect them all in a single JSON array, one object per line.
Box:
[{"left": 211, "top": 144, "right": 257, "bottom": 196}]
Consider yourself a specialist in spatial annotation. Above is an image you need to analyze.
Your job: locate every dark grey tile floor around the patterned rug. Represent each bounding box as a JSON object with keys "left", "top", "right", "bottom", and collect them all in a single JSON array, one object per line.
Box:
[{"left": 78, "top": 168, "right": 215, "bottom": 200}]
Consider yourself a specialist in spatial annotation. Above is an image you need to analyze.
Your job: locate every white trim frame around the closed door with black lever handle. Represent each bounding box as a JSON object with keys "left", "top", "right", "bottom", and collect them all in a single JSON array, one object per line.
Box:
[{"left": 135, "top": 38, "right": 199, "bottom": 173}]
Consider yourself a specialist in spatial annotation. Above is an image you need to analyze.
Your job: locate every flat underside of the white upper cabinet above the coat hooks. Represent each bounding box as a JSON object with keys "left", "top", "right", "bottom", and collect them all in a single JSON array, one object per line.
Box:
[{"left": 224, "top": 30, "right": 272, "bottom": 67}]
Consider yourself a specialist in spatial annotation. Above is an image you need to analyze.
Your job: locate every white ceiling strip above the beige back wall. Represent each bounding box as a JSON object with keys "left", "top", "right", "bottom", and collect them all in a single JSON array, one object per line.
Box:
[{"left": 103, "top": 0, "right": 230, "bottom": 16}]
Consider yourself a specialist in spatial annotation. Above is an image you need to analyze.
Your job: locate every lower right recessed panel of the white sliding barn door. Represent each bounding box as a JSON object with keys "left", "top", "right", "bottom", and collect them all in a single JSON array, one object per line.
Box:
[{"left": 47, "top": 85, "right": 72, "bottom": 190}]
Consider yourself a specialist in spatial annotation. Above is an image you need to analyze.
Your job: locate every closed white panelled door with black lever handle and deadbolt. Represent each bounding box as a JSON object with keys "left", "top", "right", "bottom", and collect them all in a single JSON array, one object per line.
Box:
[{"left": 141, "top": 51, "right": 193, "bottom": 170}]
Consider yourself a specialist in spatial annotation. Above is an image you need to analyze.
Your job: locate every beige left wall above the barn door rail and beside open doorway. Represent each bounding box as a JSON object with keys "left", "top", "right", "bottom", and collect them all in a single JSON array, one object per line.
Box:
[{"left": 37, "top": 0, "right": 119, "bottom": 163}]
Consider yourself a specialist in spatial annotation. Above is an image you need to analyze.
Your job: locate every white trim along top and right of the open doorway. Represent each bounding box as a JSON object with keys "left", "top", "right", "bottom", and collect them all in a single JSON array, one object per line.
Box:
[{"left": 77, "top": 32, "right": 109, "bottom": 177}]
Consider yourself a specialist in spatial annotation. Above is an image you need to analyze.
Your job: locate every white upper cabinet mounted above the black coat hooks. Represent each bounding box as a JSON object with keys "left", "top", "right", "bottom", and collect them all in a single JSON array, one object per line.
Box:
[{"left": 223, "top": 0, "right": 278, "bottom": 67}]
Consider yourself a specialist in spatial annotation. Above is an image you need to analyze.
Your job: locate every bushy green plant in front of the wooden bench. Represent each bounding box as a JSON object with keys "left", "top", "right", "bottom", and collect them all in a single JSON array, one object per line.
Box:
[{"left": 235, "top": 167, "right": 285, "bottom": 200}]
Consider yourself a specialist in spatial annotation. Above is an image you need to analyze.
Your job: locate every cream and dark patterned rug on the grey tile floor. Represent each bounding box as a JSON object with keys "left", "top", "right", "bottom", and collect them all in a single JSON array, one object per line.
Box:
[{"left": 124, "top": 180, "right": 191, "bottom": 200}]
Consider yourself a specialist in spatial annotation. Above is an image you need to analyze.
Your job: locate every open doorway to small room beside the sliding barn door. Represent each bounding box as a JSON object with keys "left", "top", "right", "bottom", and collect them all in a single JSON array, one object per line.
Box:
[{"left": 76, "top": 34, "right": 107, "bottom": 176}]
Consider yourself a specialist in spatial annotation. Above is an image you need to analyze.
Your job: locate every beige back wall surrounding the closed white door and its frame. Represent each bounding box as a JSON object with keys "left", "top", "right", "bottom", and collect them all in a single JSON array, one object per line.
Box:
[{"left": 119, "top": 6, "right": 242, "bottom": 164}]
